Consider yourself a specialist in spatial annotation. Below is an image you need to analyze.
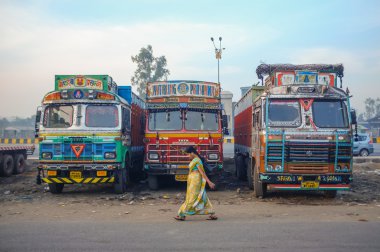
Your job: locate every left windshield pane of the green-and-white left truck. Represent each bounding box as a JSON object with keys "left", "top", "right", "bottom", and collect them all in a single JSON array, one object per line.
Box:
[{"left": 43, "top": 105, "right": 73, "bottom": 128}]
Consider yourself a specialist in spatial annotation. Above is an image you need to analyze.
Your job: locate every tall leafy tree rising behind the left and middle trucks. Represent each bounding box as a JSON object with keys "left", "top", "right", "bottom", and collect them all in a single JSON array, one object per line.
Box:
[{"left": 131, "top": 45, "right": 170, "bottom": 99}]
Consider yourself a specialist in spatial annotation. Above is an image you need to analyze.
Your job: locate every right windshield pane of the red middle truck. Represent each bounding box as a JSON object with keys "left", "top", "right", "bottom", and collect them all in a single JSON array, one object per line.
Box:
[{"left": 185, "top": 111, "right": 218, "bottom": 131}]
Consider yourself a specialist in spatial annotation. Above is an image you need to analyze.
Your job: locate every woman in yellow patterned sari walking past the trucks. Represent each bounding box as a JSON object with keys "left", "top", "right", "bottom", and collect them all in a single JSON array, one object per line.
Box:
[{"left": 174, "top": 146, "right": 218, "bottom": 221}]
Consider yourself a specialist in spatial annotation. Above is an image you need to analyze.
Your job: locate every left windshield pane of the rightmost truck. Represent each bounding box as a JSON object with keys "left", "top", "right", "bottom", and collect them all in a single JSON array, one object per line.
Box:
[{"left": 268, "top": 100, "right": 301, "bottom": 127}]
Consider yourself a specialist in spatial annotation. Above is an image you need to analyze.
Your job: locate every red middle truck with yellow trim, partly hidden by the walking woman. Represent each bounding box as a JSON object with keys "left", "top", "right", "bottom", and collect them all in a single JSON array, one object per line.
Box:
[{"left": 144, "top": 80, "right": 227, "bottom": 190}]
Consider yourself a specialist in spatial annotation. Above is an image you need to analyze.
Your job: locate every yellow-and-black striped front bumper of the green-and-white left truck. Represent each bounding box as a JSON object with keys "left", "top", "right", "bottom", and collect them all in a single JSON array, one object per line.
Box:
[{"left": 38, "top": 163, "right": 121, "bottom": 184}]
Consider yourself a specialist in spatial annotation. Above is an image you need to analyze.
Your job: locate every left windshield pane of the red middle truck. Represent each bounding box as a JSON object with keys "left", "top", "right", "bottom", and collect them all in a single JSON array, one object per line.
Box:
[{"left": 148, "top": 111, "right": 182, "bottom": 130}]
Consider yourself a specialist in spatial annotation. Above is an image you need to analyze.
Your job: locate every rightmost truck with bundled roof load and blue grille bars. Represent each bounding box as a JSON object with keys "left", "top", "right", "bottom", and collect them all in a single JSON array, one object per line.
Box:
[{"left": 234, "top": 64, "right": 356, "bottom": 197}]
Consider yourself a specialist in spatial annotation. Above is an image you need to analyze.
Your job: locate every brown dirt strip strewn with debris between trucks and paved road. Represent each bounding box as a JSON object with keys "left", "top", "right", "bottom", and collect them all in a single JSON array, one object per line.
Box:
[{"left": 0, "top": 160, "right": 380, "bottom": 221}]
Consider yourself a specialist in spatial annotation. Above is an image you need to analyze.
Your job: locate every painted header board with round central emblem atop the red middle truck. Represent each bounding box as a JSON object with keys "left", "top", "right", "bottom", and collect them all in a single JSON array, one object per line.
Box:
[{"left": 147, "top": 82, "right": 220, "bottom": 98}]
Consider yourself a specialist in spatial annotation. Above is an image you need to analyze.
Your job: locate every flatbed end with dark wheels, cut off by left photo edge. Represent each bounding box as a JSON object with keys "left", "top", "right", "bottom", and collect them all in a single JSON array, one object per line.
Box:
[{"left": 0, "top": 144, "right": 34, "bottom": 177}]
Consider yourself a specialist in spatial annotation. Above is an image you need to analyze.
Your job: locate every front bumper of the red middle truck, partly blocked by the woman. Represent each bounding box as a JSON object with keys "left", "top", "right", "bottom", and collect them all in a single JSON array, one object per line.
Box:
[{"left": 144, "top": 163, "right": 223, "bottom": 175}]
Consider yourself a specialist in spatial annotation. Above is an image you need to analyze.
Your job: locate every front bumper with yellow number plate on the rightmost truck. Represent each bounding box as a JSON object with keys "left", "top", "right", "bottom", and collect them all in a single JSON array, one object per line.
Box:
[{"left": 259, "top": 173, "right": 352, "bottom": 190}]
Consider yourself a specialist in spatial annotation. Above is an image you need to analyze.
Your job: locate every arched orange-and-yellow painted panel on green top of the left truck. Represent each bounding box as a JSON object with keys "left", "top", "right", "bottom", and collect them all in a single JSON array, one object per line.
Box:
[{"left": 58, "top": 76, "right": 103, "bottom": 90}]
